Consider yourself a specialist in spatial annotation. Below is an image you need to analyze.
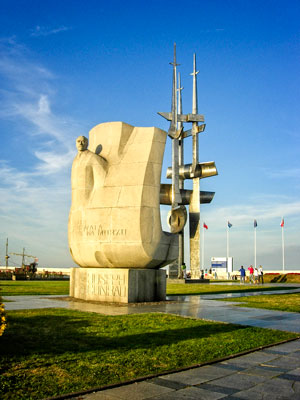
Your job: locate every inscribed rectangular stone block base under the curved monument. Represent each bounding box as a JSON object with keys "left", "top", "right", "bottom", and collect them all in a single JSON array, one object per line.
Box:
[{"left": 70, "top": 268, "right": 166, "bottom": 303}]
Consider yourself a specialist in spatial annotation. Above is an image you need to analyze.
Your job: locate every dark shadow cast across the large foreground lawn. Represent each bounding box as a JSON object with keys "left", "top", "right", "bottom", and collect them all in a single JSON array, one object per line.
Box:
[{"left": 1, "top": 314, "right": 247, "bottom": 357}]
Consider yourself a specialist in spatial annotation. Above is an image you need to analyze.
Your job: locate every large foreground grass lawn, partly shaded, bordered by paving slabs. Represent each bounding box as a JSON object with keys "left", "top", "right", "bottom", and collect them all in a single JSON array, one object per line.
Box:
[{"left": 0, "top": 309, "right": 296, "bottom": 400}]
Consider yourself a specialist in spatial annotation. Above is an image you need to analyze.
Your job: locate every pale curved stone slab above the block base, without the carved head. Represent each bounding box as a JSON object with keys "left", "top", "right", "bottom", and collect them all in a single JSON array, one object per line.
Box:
[{"left": 69, "top": 122, "right": 178, "bottom": 268}]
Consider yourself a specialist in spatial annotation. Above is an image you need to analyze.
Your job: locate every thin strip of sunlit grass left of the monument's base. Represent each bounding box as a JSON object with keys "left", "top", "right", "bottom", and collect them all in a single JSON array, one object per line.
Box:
[{"left": 0, "top": 281, "right": 70, "bottom": 297}]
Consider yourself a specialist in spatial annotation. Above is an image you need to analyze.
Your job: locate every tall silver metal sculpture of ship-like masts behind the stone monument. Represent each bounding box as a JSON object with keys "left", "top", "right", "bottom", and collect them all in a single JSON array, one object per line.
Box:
[{"left": 158, "top": 44, "right": 218, "bottom": 279}]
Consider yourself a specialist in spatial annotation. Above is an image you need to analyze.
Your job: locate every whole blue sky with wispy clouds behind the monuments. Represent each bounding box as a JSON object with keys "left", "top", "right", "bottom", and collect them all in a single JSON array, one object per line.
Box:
[{"left": 0, "top": 0, "right": 300, "bottom": 269}]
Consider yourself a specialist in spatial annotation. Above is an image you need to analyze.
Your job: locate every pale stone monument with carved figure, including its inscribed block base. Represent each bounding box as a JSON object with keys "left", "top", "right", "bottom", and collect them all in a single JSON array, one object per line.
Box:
[{"left": 68, "top": 122, "right": 178, "bottom": 303}]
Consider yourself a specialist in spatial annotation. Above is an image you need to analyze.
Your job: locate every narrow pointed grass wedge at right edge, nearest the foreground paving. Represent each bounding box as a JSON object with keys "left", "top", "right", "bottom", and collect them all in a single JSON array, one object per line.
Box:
[{"left": 220, "top": 293, "right": 300, "bottom": 313}]
